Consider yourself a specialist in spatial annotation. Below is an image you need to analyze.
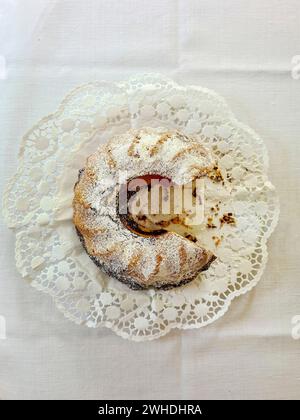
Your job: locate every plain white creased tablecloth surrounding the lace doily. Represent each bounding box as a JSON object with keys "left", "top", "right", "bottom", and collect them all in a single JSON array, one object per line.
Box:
[{"left": 0, "top": 0, "right": 300, "bottom": 399}]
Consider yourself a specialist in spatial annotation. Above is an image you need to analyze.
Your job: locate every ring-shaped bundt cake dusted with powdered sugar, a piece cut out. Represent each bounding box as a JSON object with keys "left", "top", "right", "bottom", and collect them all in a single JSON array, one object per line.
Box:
[{"left": 73, "top": 128, "right": 215, "bottom": 289}]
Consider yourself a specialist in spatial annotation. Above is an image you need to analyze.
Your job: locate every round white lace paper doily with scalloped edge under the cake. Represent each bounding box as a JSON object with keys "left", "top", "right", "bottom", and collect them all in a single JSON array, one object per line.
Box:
[{"left": 3, "top": 75, "right": 279, "bottom": 341}]
